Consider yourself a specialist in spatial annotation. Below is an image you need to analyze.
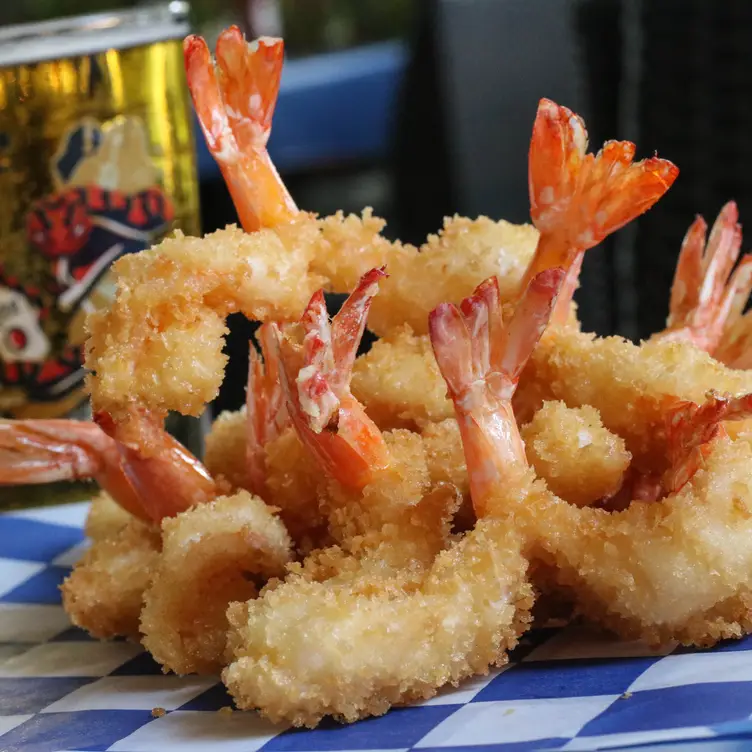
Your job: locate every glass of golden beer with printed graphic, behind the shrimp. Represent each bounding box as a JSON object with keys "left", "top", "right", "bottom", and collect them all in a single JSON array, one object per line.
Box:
[{"left": 0, "top": 2, "right": 199, "bottom": 509}]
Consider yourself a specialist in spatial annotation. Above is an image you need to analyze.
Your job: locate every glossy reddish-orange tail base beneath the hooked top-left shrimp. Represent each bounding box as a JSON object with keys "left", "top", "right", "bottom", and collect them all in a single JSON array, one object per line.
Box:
[{"left": 94, "top": 410, "right": 217, "bottom": 522}]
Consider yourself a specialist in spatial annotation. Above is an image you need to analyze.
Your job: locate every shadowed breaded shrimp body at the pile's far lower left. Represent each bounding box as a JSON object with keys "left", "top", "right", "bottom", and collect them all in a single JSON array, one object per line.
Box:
[{"left": 61, "top": 518, "right": 162, "bottom": 640}]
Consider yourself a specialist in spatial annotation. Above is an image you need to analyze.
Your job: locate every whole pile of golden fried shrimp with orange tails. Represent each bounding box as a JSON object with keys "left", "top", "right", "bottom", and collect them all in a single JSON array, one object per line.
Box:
[{"left": 7, "top": 27, "right": 752, "bottom": 727}]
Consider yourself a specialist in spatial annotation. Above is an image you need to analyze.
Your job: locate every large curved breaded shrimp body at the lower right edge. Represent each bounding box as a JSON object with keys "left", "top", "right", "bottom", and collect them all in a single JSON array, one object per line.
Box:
[{"left": 514, "top": 439, "right": 752, "bottom": 646}]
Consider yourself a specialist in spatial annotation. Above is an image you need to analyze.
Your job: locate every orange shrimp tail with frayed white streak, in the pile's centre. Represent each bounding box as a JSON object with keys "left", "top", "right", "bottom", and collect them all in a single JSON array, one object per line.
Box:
[{"left": 274, "top": 269, "right": 390, "bottom": 490}]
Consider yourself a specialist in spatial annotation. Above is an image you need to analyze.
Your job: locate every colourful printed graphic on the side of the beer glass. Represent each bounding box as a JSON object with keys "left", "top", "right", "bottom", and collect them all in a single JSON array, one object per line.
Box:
[{"left": 0, "top": 116, "right": 174, "bottom": 415}]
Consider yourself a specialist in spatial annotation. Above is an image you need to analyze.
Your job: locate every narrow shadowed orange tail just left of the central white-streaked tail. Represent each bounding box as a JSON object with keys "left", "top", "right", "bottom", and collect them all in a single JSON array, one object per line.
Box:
[{"left": 246, "top": 324, "right": 290, "bottom": 497}]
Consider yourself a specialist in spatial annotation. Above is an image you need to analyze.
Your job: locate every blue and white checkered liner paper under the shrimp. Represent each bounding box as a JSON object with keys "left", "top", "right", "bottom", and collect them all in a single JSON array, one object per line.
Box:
[{"left": 0, "top": 504, "right": 752, "bottom": 752}]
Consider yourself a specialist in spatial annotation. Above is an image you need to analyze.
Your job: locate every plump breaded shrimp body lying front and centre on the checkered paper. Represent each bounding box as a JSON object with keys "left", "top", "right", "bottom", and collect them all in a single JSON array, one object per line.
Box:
[{"left": 222, "top": 520, "right": 533, "bottom": 727}]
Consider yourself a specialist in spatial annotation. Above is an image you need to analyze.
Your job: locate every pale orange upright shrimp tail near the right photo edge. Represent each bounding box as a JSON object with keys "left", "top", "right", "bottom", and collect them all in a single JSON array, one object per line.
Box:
[{"left": 656, "top": 201, "right": 752, "bottom": 353}]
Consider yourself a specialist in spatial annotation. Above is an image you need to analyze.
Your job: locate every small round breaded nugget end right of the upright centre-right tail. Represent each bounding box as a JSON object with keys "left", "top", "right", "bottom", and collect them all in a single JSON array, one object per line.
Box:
[{"left": 520, "top": 402, "right": 632, "bottom": 507}]
